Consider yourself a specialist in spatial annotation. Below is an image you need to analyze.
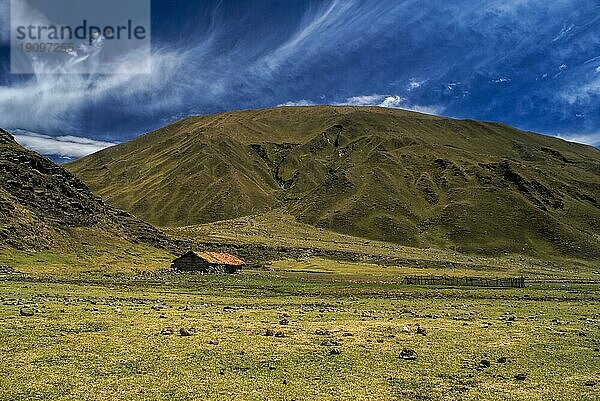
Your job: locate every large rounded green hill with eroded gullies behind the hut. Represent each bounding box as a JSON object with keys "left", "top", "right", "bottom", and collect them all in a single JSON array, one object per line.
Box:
[{"left": 66, "top": 106, "right": 600, "bottom": 259}]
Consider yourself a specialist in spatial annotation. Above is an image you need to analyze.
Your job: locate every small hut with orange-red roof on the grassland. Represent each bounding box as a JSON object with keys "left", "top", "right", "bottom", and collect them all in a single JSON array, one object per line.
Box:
[{"left": 171, "top": 251, "right": 246, "bottom": 274}]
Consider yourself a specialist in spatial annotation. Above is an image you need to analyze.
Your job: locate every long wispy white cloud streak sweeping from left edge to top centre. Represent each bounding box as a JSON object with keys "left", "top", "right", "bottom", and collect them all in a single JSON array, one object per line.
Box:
[{"left": 0, "top": 0, "right": 376, "bottom": 132}]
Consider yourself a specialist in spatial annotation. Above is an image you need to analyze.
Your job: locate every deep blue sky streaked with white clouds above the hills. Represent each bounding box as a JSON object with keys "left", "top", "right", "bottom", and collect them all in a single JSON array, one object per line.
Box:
[{"left": 0, "top": 0, "right": 600, "bottom": 157}]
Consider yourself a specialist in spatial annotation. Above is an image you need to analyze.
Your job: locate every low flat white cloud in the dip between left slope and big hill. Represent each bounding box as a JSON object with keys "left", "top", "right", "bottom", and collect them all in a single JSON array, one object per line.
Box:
[{"left": 11, "top": 129, "right": 116, "bottom": 158}]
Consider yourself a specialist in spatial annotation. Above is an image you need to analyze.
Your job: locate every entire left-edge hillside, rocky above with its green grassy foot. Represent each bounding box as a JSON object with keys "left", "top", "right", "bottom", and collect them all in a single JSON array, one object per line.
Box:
[{"left": 0, "top": 130, "right": 169, "bottom": 272}]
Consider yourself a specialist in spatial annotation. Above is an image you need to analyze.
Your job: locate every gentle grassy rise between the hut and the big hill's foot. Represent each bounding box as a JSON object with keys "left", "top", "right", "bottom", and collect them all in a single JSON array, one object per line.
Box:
[{"left": 164, "top": 210, "right": 600, "bottom": 279}]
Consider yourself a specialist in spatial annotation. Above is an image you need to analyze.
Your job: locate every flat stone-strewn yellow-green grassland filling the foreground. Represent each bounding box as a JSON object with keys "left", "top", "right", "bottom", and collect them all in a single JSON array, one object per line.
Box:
[{"left": 0, "top": 259, "right": 600, "bottom": 401}]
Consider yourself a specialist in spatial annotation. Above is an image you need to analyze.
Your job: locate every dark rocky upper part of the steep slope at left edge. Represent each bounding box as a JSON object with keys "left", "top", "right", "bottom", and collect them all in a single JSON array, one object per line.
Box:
[{"left": 0, "top": 130, "right": 167, "bottom": 249}]
